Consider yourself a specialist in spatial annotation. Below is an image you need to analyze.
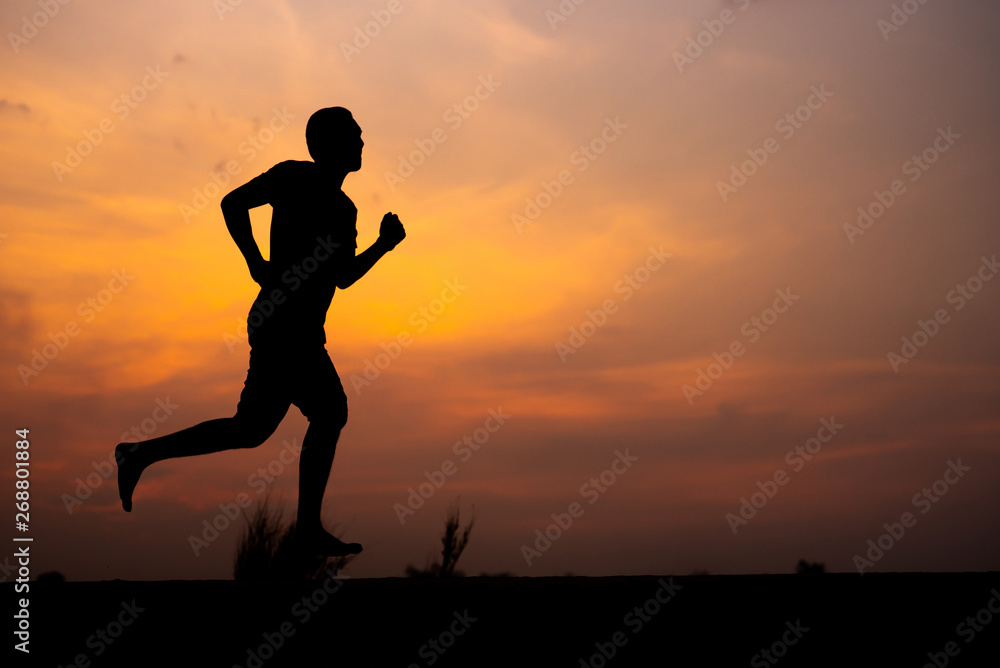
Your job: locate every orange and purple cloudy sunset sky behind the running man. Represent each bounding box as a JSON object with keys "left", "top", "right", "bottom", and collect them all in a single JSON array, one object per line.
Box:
[{"left": 0, "top": 0, "right": 1000, "bottom": 580}]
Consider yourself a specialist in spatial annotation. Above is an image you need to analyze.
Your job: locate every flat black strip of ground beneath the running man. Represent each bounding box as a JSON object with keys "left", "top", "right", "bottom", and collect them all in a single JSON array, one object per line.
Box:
[{"left": 15, "top": 573, "right": 1000, "bottom": 668}]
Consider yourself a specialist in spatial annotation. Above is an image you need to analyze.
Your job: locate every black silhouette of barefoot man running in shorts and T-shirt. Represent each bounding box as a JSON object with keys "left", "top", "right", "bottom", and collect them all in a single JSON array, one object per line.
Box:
[{"left": 115, "top": 107, "right": 406, "bottom": 556}]
